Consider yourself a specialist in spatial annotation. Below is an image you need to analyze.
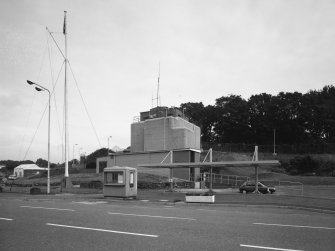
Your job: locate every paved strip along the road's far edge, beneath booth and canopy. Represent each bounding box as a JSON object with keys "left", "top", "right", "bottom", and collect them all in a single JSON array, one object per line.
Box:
[{"left": 0, "top": 187, "right": 335, "bottom": 214}]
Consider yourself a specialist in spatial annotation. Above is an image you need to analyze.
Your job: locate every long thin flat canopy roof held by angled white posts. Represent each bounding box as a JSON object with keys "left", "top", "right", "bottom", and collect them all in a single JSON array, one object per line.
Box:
[{"left": 137, "top": 160, "right": 280, "bottom": 168}]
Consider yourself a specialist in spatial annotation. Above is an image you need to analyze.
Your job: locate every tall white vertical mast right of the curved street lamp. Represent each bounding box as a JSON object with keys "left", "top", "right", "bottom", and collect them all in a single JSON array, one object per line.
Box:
[{"left": 63, "top": 11, "right": 69, "bottom": 178}]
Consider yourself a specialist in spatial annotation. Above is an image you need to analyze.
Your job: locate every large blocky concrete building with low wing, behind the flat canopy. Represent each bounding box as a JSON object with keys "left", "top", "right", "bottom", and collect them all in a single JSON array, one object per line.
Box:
[{"left": 96, "top": 107, "right": 200, "bottom": 180}]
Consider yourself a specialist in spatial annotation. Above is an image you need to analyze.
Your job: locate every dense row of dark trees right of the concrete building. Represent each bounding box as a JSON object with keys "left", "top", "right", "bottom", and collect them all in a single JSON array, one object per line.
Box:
[{"left": 180, "top": 85, "right": 335, "bottom": 145}]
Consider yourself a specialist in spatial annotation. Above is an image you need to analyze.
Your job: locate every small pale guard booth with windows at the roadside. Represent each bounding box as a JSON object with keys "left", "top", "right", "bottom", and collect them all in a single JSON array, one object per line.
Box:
[{"left": 103, "top": 166, "right": 137, "bottom": 198}]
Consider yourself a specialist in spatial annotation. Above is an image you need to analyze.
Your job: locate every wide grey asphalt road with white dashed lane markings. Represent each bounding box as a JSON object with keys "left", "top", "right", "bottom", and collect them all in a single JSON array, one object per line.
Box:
[{"left": 0, "top": 195, "right": 335, "bottom": 251}]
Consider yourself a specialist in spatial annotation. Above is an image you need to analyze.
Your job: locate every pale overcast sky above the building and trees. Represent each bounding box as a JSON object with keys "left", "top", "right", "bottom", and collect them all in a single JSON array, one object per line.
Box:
[{"left": 0, "top": 0, "right": 335, "bottom": 163}]
